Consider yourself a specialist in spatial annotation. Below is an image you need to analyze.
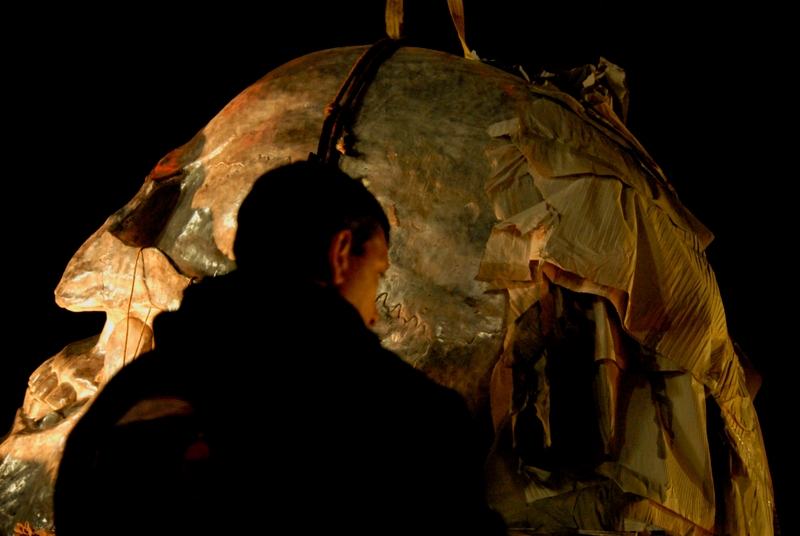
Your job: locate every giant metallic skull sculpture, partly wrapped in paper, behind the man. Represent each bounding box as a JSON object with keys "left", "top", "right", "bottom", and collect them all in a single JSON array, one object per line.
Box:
[{"left": 0, "top": 48, "right": 772, "bottom": 534}]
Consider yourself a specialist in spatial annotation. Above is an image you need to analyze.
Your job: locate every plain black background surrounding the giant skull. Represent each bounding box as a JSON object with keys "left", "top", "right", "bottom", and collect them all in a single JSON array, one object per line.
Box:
[{"left": 0, "top": 0, "right": 798, "bottom": 533}]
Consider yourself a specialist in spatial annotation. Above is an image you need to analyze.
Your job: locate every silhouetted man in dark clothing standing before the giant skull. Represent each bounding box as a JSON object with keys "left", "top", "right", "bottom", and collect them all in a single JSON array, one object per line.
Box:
[{"left": 55, "top": 163, "right": 505, "bottom": 536}]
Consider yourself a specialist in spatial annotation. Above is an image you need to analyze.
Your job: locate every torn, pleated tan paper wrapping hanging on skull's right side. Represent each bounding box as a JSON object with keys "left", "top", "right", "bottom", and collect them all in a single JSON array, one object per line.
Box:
[{"left": 484, "top": 87, "right": 772, "bottom": 534}]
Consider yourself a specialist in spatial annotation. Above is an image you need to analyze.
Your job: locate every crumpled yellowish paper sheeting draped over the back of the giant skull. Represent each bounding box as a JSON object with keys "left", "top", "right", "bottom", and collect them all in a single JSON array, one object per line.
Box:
[{"left": 477, "top": 88, "right": 773, "bottom": 534}]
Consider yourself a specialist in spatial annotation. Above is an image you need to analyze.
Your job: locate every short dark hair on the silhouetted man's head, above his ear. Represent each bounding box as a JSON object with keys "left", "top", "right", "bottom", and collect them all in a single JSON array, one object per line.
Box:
[{"left": 234, "top": 162, "right": 389, "bottom": 281}]
